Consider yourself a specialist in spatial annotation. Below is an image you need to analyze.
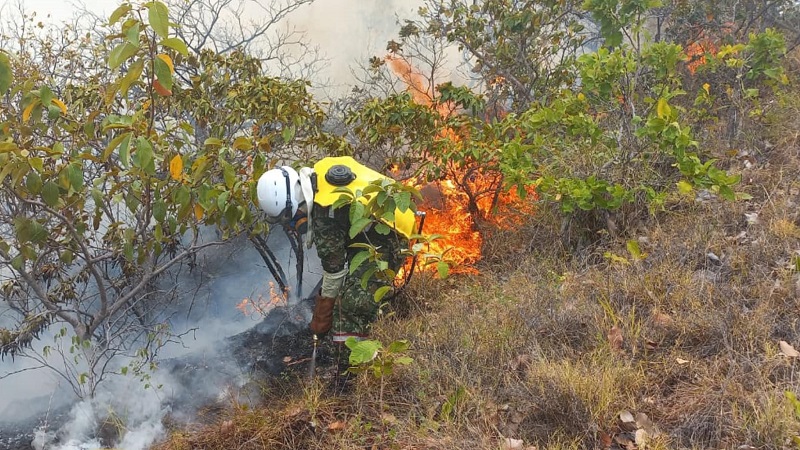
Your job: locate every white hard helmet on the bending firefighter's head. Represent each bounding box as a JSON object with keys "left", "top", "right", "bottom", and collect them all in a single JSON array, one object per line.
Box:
[{"left": 257, "top": 166, "right": 304, "bottom": 223}]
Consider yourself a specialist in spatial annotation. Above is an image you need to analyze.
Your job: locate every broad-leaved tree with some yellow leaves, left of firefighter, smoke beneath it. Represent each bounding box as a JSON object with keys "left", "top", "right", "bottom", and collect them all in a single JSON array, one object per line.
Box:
[{"left": 0, "top": 1, "right": 332, "bottom": 395}]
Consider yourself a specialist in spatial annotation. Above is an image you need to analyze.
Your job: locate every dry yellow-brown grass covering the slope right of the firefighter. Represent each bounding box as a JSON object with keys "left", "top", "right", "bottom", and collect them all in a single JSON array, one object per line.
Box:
[{"left": 152, "top": 92, "right": 800, "bottom": 450}]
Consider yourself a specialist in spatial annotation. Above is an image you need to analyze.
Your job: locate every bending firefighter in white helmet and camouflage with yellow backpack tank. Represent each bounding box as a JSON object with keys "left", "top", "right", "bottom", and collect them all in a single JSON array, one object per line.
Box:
[{"left": 257, "top": 156, "right": 415, "bottom": 343}]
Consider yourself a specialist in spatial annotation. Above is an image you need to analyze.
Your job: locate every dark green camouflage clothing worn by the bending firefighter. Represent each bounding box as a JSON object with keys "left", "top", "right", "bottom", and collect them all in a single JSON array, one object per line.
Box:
[{"left": 313, "top": 205, "right": 408, "bottom": 342}]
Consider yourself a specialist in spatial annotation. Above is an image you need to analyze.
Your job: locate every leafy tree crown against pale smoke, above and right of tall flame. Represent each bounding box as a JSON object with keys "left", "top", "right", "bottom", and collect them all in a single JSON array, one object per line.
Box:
[{"left": 416, "top": 0, "right": 590, "bottom": 111}]
